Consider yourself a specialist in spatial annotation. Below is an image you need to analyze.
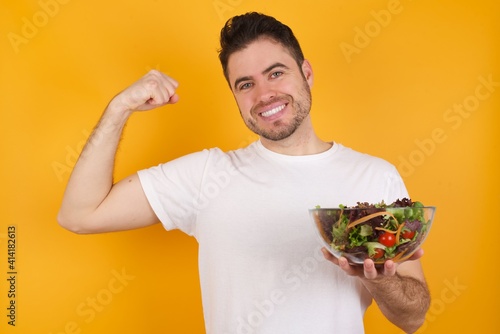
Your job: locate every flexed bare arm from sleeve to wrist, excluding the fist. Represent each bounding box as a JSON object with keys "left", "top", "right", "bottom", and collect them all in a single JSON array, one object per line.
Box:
[{"left": 58, "top": 106, "right": 157, "bottom": 233}]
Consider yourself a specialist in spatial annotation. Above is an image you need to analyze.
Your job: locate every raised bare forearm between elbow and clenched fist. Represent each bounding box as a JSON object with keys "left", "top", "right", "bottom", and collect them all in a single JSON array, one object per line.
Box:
[{"left": 58, "top": 104, "right": 129, "bottom": 232}]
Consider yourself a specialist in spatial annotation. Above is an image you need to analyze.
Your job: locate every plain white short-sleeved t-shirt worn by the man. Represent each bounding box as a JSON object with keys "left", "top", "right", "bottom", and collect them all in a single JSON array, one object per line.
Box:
[{"left": 139, "top": 141, "right": 408, "bottom": 334}]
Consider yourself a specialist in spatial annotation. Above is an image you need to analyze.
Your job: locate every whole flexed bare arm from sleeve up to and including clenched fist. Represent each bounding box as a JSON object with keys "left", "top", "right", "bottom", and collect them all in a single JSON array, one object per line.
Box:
[{"left": 57, "top": 71, "right": 178, "bottom": 233}]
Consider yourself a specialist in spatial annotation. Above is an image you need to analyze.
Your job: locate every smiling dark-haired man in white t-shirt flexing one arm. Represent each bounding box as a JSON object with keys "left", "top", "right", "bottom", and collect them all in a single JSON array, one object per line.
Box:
[{"left": 58, "top": 13, "right": 429, "bottom": 334}]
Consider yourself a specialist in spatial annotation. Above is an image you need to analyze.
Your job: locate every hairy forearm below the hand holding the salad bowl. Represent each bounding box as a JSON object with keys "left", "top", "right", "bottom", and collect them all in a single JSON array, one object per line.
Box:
[{"left": 363, "top": 274, "right": 430, "bottom": 333}]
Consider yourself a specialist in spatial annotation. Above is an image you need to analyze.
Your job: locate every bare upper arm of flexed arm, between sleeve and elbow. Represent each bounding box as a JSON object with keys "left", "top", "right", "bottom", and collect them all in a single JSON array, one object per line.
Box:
[{"left": 86, "top": 173, "right": 158, "bottom": 233}]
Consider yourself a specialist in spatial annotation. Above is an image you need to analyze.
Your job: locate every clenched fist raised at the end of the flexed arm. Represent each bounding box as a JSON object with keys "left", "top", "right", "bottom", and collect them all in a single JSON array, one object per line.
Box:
[{"left": 108, "top": 70, "right": 179, "bottom": 113}]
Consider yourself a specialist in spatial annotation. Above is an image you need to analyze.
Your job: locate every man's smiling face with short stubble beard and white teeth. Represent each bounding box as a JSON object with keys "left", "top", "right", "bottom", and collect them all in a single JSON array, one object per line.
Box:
[{"left": 228, "top": 38, "right": 313, "bottom": 141}]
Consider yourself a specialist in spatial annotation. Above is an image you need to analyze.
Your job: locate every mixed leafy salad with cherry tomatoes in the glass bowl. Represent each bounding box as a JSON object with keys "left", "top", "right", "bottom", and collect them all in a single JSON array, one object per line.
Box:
[{"left": 316, "top": 198, "right": 430, "bottom": 263}]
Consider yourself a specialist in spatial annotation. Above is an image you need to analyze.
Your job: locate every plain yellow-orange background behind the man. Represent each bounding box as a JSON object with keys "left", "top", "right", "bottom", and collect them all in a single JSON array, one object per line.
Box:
[{"left": 0, "top": 0, "right": 500, "bottom": 334}]
